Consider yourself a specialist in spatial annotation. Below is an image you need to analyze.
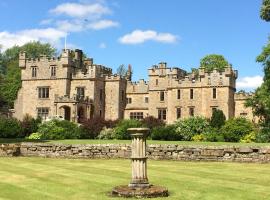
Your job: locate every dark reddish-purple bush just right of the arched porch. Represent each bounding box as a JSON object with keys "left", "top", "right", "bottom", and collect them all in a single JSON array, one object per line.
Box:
[{"left": 82, "top": 117, "right": 117, "bottom": 139}]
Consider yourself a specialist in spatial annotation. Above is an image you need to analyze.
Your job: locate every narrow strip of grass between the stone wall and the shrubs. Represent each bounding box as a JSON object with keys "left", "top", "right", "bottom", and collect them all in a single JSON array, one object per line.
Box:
[{"left": 0, "top": 138, "right": 270, "bottom": 146}]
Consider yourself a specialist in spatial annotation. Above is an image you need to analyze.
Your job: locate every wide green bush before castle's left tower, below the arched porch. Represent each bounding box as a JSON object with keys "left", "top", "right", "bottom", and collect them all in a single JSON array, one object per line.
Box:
[{"left": 38, "top": 120, "right": 82, "bottom": 140}]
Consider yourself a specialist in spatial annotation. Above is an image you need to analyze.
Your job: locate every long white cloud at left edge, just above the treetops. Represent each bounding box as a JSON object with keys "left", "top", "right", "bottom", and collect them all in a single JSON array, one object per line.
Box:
[{"left": 0, "top": 28, "right": 66, "bottom": 51}]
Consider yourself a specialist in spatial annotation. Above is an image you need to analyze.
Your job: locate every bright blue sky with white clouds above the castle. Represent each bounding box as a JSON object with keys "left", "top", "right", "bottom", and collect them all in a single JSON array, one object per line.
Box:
[{"left": 0, "top": 0, "right": 269, "bottom": 90}]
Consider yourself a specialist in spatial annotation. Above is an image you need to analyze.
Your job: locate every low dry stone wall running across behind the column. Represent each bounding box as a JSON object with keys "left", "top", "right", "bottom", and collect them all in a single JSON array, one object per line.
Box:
[{"left": 0, "top": 143, "right": 270, "bottom": 163}]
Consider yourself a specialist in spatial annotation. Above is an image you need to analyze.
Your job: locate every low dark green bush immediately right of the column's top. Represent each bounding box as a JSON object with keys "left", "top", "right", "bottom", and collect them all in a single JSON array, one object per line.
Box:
[{"left": 151, "top": 125, "right": 179, "bottom": 141}]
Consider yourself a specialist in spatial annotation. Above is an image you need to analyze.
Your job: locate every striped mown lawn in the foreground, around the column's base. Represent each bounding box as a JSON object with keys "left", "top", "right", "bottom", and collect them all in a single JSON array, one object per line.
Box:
[{"left": 0, "top": 157, "right": 270, "bottom": 200}]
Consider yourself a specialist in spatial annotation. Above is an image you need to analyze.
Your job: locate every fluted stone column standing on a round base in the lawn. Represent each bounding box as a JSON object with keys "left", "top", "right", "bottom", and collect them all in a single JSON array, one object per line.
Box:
[{"left": 128, "top": 128, "right": 149, "bottom": 188}]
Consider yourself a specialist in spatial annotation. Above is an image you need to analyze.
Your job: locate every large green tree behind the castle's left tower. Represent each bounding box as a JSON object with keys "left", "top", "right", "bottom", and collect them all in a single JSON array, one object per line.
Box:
[{"left": 0, "top": 42, "right": 56, "bottom": 107}]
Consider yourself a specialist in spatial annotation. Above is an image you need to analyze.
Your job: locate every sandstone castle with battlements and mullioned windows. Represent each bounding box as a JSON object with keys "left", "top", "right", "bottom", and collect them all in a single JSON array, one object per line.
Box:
[{"left": 13, "top": 49, "right": 253, "bottom": 123}]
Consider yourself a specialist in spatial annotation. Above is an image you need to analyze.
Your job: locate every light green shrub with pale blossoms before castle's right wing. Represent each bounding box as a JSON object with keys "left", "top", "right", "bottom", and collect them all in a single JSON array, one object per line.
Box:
[{"left": 175, "top": 116, "right": 209, "bottom": 141}]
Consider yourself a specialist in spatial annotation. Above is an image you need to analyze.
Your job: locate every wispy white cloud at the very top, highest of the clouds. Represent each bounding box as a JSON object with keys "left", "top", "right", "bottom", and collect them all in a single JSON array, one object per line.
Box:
[{"left": 50, "top": 3, "right": 111, "bottom": 19}]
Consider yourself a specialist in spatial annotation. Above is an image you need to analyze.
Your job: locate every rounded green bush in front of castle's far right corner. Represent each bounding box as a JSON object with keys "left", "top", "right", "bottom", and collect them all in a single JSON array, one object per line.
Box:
[{"left": 220, "top": 117, "right": 254, "bottom": 142}]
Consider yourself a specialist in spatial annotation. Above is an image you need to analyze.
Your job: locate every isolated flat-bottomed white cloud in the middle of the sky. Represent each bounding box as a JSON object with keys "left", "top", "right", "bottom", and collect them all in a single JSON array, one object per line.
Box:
[{"left": 119, "top": 30, "right": 178, "bottom": 44}]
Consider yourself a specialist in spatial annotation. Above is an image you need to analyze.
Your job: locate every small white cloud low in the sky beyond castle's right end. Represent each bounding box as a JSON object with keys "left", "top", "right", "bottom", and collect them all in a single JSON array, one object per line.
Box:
[{"left": 236, "top": 75, "right": 263, "bottom": 89}]
